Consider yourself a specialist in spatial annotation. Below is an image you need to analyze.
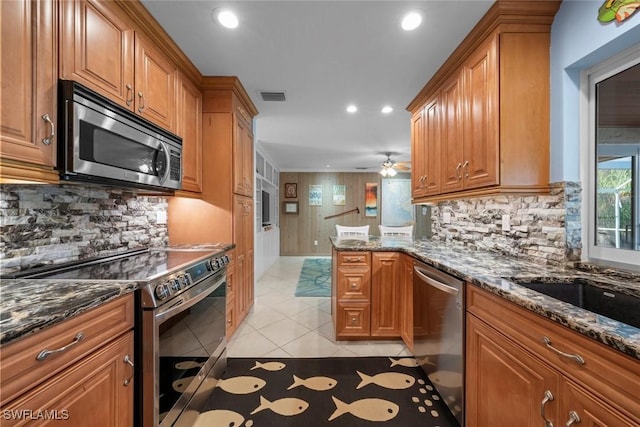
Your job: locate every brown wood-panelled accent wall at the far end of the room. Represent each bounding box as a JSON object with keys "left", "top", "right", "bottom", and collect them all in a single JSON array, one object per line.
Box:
[{"left": 279, "top": 172, "right": 382, "bottom": 256}]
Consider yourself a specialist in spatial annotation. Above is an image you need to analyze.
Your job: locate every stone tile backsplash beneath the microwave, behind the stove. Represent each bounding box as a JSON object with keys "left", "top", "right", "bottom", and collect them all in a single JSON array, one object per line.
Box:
[{"left": 0, "top": 184, "right": 168, "bottom": 274}]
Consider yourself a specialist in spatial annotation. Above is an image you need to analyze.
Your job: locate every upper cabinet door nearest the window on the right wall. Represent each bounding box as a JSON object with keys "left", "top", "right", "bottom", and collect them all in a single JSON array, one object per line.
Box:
[{"left": 462, "top": 38, "right": 500, "bottom": 189}]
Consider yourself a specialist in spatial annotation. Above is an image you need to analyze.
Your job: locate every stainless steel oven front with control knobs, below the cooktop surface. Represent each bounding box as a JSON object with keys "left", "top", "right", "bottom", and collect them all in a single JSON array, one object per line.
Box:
[{"left": 140, "top": 257, "right": 228, "bottom": 427}]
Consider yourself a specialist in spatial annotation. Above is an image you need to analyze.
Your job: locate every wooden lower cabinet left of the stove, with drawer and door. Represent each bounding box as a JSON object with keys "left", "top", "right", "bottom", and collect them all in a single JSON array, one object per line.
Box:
[{"left": 0, "top": 294, "right": 136, "bottom": 427}]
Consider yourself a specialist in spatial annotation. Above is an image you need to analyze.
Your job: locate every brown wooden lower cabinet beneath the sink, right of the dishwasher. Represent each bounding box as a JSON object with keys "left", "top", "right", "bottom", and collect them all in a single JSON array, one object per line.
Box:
[{"left": 465, "top": 285, "right": 640, "bottom": 427}]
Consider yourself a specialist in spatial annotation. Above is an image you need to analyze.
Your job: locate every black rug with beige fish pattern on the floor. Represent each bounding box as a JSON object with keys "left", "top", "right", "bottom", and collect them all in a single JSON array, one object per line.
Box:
[{"left": 195, "top": 357, "right": 458, "bottom": 427}]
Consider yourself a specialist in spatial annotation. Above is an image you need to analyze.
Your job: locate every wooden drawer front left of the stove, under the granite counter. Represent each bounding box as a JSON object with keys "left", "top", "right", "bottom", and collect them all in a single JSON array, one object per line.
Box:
[{"left": 0, "top": 294, "right": 134, "bottom": 406}]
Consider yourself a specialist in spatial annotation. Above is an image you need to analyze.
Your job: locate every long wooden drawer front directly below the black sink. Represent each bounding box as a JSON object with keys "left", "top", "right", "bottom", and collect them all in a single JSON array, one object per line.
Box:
[{"left": 467, "top": 286, "right": 640, "bottom": 420}]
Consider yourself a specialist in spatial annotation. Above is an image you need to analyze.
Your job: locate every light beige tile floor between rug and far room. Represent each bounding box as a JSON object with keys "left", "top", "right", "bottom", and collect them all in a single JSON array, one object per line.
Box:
[{"left": 227, "top": 257, "right": 410, "bottom": 357}]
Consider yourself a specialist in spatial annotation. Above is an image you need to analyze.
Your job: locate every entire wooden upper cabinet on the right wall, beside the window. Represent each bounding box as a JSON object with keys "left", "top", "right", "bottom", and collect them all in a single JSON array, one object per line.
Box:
[{"left": 407, "top": 1, "right": 560, "bottom": 203}]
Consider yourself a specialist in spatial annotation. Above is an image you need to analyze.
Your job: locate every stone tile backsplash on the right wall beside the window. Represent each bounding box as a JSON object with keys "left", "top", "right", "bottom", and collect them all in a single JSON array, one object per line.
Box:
[{"left": 431, "top": 182, "right": 582, "bottom": 265}]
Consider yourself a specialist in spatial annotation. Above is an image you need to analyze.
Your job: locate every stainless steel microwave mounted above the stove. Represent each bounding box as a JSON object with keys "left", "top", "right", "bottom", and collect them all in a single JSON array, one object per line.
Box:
[{"left": 58, "top": 80, "right": 182, "bottom": 190}]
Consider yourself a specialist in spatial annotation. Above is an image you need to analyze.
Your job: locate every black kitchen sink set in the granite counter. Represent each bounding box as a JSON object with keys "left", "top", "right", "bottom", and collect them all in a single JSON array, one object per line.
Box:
[{"left": 507, "top": 277, "right": 640, "bottom": 328}]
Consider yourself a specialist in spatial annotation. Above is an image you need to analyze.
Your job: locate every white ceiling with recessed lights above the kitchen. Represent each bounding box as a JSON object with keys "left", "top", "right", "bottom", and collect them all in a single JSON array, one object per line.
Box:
[{"left": 142, "top": 0, "right": 493, "bottom": 172}]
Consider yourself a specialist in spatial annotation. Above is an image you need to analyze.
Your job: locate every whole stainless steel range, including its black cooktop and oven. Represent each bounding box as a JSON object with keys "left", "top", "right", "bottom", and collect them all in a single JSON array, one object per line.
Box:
[{"left": 7, "top": 245, "right": 229, "bottom": 427}]
